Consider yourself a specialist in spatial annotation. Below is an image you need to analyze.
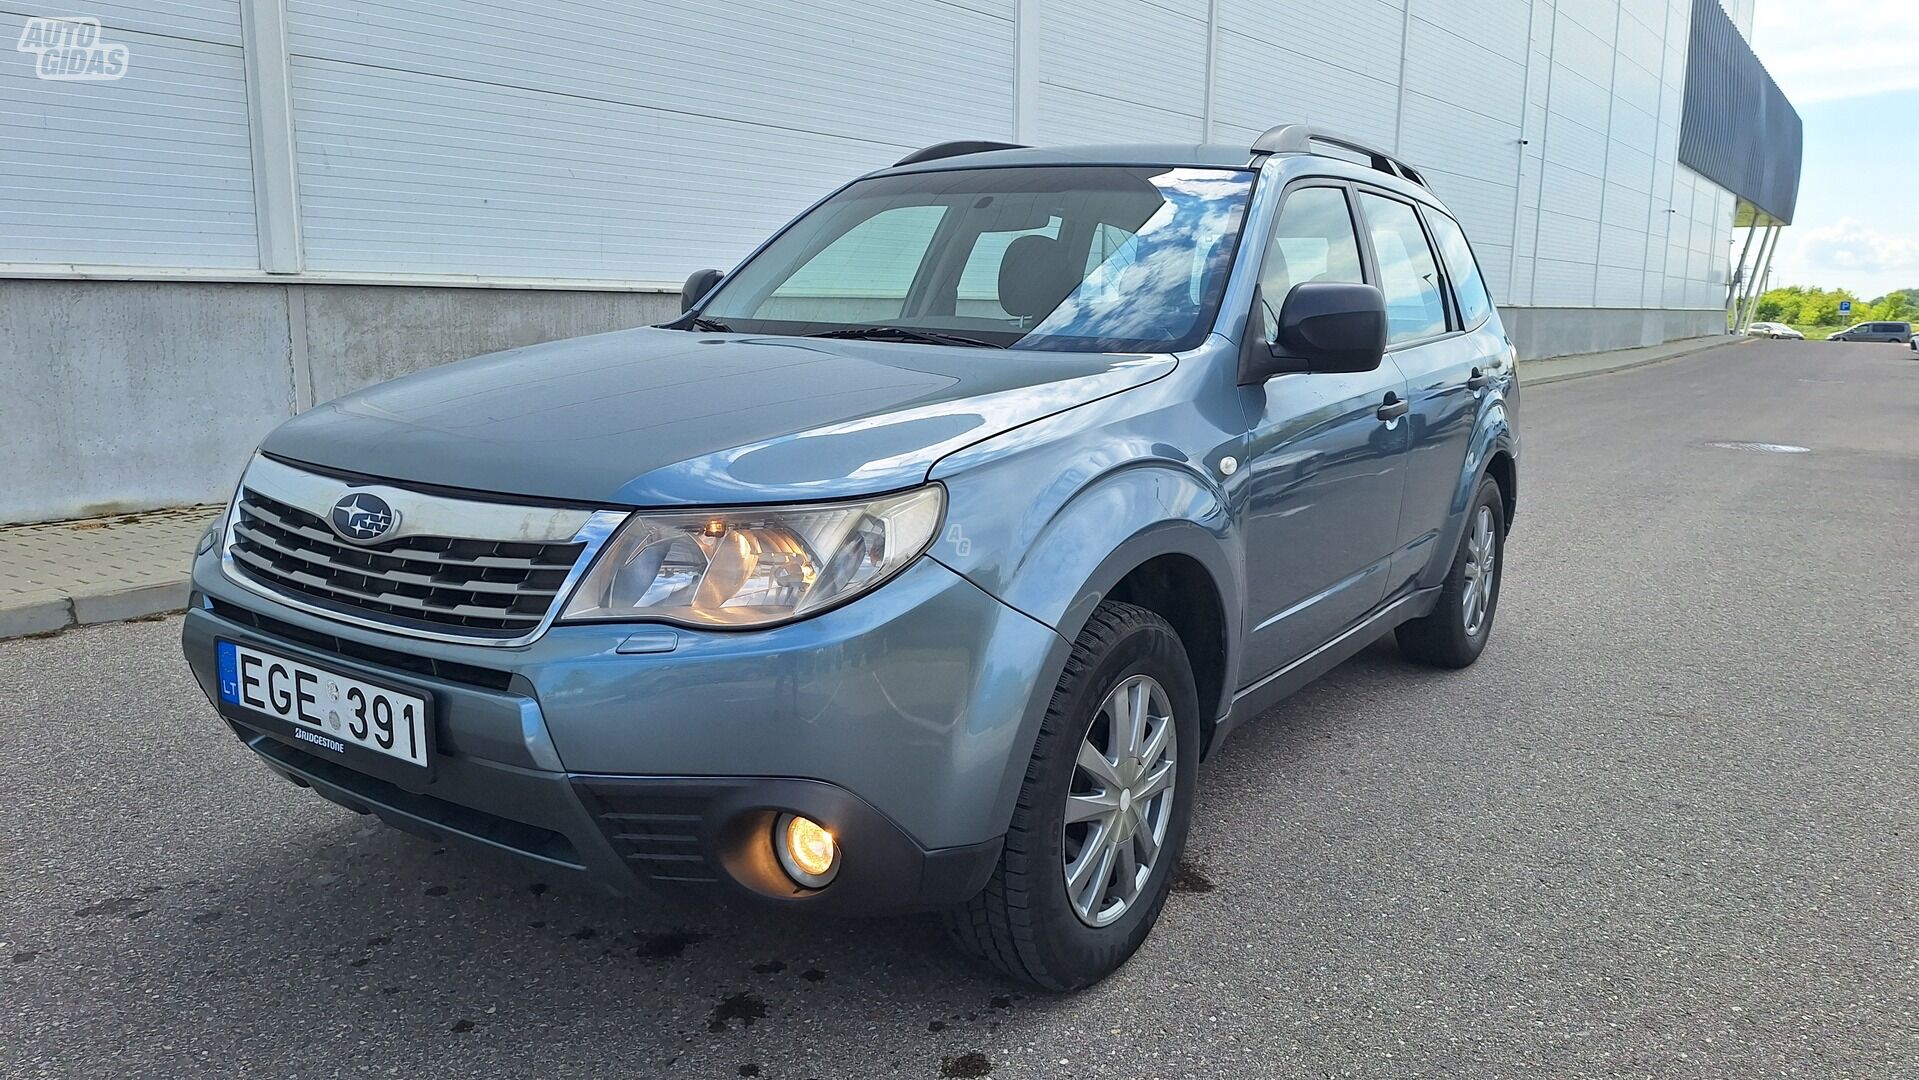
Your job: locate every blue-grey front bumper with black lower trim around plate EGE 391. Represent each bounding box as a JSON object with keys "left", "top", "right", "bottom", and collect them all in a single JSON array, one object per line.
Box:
[{"left": 182, "top": 556, "right": 1067, "bottom": 911}]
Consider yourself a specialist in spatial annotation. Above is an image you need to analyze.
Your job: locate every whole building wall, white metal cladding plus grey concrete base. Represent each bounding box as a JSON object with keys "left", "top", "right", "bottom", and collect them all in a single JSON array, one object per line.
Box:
[{"left": 0, "top": 0, "right": 1780, "bottom": 522}]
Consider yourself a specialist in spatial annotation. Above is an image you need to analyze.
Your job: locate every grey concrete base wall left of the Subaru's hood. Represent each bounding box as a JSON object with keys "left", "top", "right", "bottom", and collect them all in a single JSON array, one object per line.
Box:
[{"left": 0, "top": 280, "right": 679, "bottom": 524}]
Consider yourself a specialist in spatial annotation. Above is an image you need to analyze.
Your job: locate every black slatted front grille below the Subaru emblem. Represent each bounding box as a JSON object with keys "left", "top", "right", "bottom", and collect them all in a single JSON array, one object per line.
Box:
[{"left": 228, "top": 487, "right": 585, "bottom": 639}]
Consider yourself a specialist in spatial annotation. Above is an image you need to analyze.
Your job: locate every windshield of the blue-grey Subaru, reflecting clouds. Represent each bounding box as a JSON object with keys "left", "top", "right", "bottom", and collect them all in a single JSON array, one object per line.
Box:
[{"left": 699, "top": 165, "right": 1253, "bottom": 351}]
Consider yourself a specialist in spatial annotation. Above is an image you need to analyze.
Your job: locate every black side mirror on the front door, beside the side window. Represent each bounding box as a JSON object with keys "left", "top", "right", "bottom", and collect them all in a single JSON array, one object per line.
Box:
[{"left": 1240, "top": 282, "right": 1386, "bottom": 386}]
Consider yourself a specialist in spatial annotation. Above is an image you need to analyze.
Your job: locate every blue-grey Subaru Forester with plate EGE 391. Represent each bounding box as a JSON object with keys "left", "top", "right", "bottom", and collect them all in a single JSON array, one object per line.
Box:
[{"left": 184, "top": 125, "right": 1518, "bottom": 990}]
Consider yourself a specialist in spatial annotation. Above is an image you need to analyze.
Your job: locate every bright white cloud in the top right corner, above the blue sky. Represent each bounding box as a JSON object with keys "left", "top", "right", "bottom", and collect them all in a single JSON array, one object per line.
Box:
[{"left": 1752, "top": 0, "right": 1919, "bottom": 106}]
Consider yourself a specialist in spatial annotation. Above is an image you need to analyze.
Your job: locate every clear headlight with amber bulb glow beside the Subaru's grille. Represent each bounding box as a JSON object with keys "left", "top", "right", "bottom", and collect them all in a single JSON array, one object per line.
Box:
[{"left": 560, "top": 483, "right": 946, "bottom": 627}]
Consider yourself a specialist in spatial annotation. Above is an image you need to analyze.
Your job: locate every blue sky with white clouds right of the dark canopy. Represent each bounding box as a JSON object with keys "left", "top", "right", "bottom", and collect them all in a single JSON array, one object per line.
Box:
[{"left": 1757, "top": 0, "right": 1919, "bottom": 299}]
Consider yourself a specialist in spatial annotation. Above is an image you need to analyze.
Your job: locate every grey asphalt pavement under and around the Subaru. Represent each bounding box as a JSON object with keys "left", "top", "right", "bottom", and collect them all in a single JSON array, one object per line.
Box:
[{"left": 0, "top": 341, "right": 1919, "bottom": 1080}]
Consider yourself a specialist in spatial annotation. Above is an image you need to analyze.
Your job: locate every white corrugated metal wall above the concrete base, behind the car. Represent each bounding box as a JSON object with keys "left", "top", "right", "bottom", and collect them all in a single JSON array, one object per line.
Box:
[{"left": 0, "top": 0, "right": 1752, "bottom": 309}]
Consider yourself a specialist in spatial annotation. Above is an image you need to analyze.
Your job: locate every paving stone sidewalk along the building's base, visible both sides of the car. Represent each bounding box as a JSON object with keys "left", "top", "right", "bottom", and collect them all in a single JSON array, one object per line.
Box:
[{"left": 0, "top": 338, "right": 1741, "bottom": 639}]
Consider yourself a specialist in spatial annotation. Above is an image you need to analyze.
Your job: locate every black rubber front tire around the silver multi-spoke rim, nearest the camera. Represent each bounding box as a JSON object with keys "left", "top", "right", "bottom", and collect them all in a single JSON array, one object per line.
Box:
[{"left": 946, "top": 600, "right": 1199, "bottom": 992}]
